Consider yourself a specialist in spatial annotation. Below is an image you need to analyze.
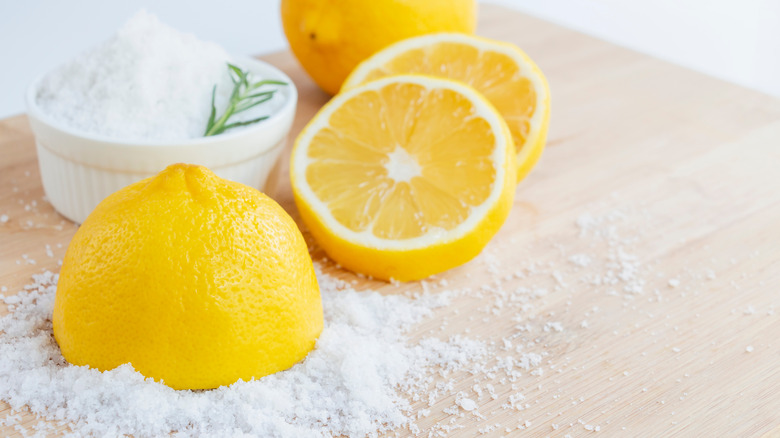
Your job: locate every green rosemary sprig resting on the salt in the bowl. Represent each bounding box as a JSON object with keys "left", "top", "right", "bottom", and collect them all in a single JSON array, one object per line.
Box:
[{"left": 203, "top": 63, "right": 287, "bottom": 137}]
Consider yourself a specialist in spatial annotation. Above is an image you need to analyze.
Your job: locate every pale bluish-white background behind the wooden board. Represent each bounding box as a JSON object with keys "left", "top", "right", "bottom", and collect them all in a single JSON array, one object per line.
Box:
[{"left": 0, "top": 0, "right": 780, "bottom": 118}]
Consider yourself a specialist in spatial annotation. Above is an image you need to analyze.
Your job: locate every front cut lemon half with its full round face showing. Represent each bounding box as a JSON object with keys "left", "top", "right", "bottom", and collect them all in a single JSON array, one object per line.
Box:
[{"left": 290, "top": 75, "right": 516, "bottom": 281}]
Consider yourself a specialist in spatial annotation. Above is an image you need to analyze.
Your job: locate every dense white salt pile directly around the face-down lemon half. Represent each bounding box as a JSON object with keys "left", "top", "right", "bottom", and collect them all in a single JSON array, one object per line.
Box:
[{"left": 0, "top": 269, "right": 485, "bottom": 438}]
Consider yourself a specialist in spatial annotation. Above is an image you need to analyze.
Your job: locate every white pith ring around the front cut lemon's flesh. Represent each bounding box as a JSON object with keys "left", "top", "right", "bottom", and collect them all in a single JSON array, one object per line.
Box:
[{"left": 292, "top": 75, "right": 508, "bottom": 250}]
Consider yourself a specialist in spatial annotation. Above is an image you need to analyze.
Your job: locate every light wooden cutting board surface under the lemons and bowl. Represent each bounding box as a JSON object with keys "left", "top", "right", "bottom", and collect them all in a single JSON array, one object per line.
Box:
[{"left": 0, "top": 5, "right": 780, "bottom": 437}]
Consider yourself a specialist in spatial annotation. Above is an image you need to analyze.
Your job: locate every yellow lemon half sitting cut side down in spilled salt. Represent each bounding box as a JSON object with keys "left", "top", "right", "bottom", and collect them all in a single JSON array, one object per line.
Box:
[{"left": 52, "top": 164, "right": 323, "bottom": 389}]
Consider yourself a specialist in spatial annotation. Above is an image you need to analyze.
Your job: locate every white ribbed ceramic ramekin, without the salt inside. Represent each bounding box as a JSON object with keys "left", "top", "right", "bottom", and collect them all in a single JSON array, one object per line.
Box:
[{"left": 27, "top": 58, "right": 298, "bottom": 223}]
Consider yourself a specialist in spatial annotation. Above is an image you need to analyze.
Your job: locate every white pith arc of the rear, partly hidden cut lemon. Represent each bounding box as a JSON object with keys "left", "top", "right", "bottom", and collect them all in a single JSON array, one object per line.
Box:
[{"left": 345, "top": 33, "right": 547, "bottom": 165}]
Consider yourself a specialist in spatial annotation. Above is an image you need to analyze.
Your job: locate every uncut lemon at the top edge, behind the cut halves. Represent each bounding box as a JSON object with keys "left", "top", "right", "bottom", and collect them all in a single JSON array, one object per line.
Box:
[{"left": 282, "top": 0, "right": 477, "bottom": 94}]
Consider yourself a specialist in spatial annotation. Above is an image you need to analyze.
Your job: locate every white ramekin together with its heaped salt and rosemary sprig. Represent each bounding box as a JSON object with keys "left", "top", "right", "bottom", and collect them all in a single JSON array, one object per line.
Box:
[{"left": 26, "top": 11, "right": 297, "bottom": 223}]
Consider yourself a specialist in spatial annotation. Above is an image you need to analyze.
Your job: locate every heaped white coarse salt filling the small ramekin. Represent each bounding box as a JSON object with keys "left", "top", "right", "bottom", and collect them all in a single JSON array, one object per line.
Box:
[{"left": 36, "top": 10, "right": 284, "bottom": 141}]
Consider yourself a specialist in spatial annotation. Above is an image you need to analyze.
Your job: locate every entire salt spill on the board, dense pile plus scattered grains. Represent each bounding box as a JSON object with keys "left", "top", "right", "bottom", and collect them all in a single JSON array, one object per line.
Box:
[{"left": 0, "top": 205, "right": 736, "bottom": 437}]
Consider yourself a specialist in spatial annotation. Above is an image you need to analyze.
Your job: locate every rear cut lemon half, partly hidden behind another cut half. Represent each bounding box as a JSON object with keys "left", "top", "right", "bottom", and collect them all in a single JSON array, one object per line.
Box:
[{"left": 341, "top": 33, "right": 550, "bottom": 182}]
